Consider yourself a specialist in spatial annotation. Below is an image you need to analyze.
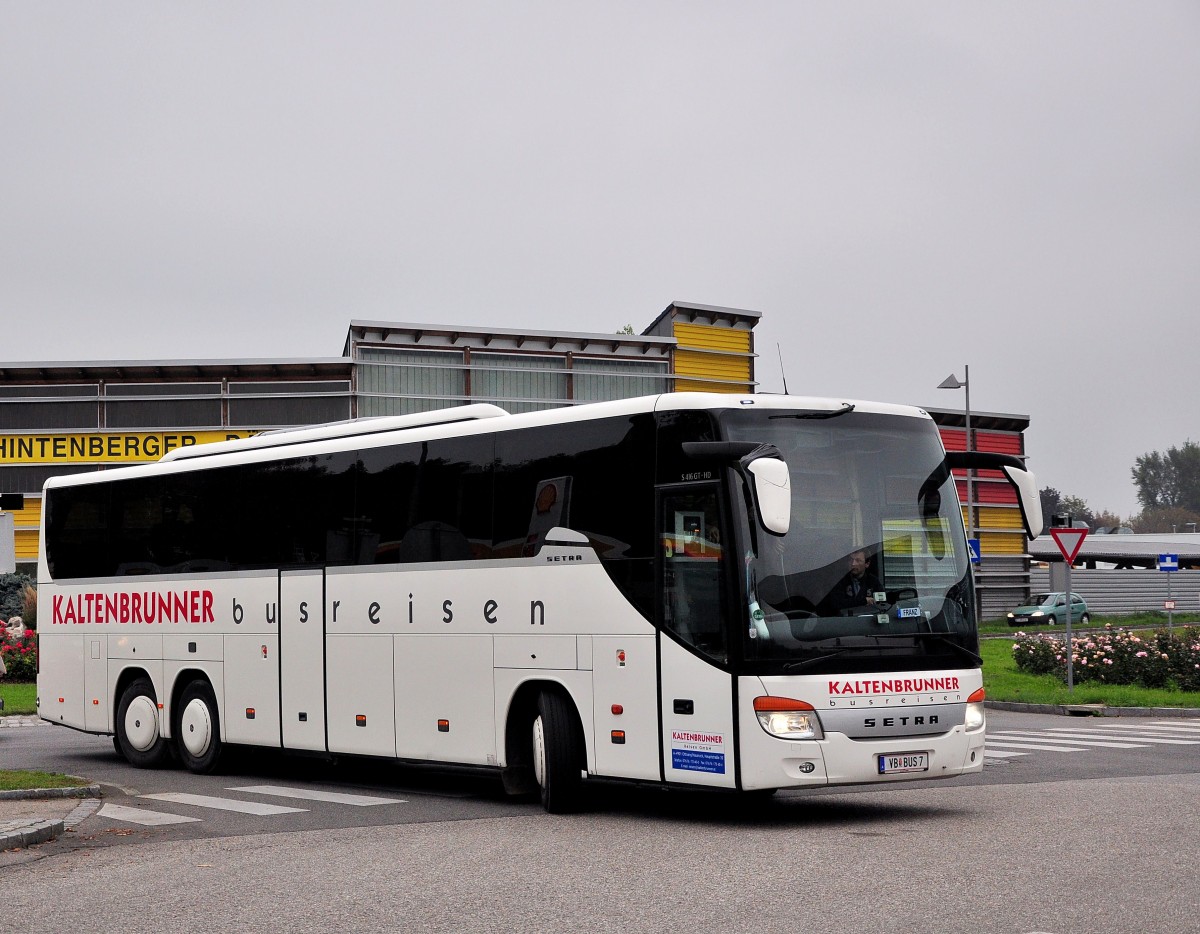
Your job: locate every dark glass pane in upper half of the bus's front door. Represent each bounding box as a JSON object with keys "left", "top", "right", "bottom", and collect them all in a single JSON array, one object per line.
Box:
[{"left": 660, "top": 490, "right": 727, "bottom": 661}]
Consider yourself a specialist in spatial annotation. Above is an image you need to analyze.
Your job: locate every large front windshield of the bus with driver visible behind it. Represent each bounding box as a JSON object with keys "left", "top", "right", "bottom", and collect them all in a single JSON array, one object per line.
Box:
[{"left": 721, "top": 406, "right": 979, "bottom": 673}]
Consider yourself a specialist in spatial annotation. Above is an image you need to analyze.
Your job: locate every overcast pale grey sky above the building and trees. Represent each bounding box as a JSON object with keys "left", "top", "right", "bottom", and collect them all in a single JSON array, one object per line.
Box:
[{"left": 0, "top": 0, "right": 1200, "bottom": 515}]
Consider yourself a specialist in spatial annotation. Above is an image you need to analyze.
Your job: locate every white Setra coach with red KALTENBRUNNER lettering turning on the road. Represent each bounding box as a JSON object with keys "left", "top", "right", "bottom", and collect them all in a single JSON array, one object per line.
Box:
[{"left": 37, "top": 393, "right": 1042, "bottom": 812}]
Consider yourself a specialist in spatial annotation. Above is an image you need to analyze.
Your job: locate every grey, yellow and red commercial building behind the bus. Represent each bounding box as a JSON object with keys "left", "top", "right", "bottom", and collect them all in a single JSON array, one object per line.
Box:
[{"left": 0, "top": 301, "right": 1030, "bottom": 615}]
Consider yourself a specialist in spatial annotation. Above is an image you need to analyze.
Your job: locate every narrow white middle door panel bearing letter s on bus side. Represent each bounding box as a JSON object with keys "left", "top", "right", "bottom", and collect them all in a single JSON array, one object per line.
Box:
[{"left": 280, "top": 570, "right": 325, "bottom": 752}]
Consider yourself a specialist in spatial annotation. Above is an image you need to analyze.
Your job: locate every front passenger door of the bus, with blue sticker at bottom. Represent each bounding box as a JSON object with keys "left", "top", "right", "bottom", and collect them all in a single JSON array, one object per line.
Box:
[{"left": 659, "top": 484, "right": 736, "bottom": 788}]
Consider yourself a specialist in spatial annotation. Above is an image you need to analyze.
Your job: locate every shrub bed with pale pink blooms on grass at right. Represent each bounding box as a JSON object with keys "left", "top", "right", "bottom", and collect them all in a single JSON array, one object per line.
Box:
[{"left": 1013, "top": 625, "right": 1200, "bottom": 691}]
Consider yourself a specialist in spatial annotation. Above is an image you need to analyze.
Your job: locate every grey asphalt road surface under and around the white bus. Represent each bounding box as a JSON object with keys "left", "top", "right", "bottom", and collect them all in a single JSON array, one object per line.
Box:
[{"left": 0, "top": 712, "right": 1200, "bottom": 934}]
